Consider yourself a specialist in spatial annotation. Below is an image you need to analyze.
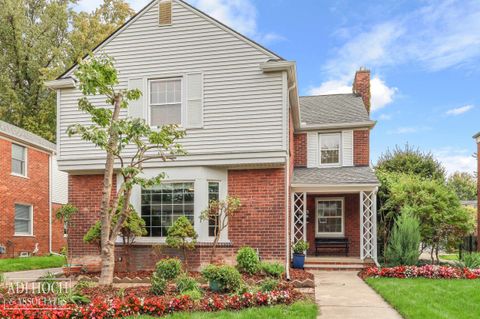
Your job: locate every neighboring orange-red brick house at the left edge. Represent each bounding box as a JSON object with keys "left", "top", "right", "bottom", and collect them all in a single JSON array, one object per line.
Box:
[{"left": 0, "top": 121, "right": 68, "bottom": 258}]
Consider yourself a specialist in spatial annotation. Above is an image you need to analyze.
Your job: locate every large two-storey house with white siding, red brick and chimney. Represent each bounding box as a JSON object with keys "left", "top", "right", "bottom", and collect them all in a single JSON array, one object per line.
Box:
[{"left": 47, "top": 0, "right": 378, "bottom": 269}]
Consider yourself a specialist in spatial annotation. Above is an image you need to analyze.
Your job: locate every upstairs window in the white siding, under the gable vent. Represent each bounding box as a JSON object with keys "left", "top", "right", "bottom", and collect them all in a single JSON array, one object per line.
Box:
[{"left": 149, "top": 78, "right": 182, "bottom": 126}]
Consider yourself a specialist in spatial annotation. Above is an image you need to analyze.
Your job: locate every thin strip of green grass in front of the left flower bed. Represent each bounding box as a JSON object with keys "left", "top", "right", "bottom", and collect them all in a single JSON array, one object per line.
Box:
[{"left": 125, "top": 301, "right": 317, "bottom": 319}]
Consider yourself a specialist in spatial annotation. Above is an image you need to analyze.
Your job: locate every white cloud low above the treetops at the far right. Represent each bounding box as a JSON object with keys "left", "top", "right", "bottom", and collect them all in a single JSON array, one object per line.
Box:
[{"left": 432, "top": 147, "right": 477, "bottom": 174}]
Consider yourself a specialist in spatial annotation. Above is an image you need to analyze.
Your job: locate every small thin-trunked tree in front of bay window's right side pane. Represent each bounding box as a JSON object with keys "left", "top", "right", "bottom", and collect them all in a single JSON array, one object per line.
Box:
[{"left": 200, "top": 196, "right": 241, "bottom": 262}]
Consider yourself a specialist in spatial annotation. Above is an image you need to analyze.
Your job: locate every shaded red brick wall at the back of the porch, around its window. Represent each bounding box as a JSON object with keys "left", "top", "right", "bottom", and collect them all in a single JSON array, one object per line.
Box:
[{"left": 307, "top": 194, "right": 360, "bottom": 257}]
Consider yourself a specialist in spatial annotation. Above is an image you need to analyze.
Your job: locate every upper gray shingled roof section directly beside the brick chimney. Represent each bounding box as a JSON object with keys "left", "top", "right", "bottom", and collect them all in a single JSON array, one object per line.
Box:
[{"left": 300, "top": 93, "right": 370, "bottom": 125}]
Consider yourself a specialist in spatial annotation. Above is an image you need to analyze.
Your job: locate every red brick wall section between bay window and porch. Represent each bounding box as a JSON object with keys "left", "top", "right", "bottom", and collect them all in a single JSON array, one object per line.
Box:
[{"left": 228, "top": 168, "right": 285, "bottom": 260}]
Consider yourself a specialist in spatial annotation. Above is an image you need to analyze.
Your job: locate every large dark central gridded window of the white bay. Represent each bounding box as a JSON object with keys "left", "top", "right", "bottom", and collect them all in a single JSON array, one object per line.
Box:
[{"left": 141, "top": 182, "right": 195, "bottom": 237}]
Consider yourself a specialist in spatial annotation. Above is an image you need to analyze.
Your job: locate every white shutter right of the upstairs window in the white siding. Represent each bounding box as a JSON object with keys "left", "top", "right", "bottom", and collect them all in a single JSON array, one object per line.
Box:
[{"left": 185, "top": 73, "right": 203, "bottom": 128}]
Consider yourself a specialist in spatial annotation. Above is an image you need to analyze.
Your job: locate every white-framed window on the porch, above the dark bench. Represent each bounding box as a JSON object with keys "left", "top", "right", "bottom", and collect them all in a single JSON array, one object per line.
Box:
[{"left": 315, "top": 198, "right": 345, "bottom": 236}]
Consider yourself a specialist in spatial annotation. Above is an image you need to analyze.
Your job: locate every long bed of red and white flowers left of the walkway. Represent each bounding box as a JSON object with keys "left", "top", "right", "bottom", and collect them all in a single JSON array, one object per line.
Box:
[{"left": 0, "top": 289, "right": 299, "bottom": 319}]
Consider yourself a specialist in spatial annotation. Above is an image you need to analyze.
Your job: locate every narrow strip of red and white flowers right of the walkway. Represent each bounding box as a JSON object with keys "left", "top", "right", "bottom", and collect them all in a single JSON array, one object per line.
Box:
[{"left": 360, "top": 265, "right": 480, "bottom": 279}]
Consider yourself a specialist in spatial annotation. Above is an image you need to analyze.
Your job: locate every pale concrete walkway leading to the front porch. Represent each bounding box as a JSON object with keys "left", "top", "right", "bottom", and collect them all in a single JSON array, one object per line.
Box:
[{"left": 312, "top": 271, "right": 402, "bottom": 319}]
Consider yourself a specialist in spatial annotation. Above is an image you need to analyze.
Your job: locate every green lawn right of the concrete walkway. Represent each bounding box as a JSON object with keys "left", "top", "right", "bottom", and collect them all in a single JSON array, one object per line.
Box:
[{"left": 366, "top": 278, "right": 480, "bottom": 319}]
